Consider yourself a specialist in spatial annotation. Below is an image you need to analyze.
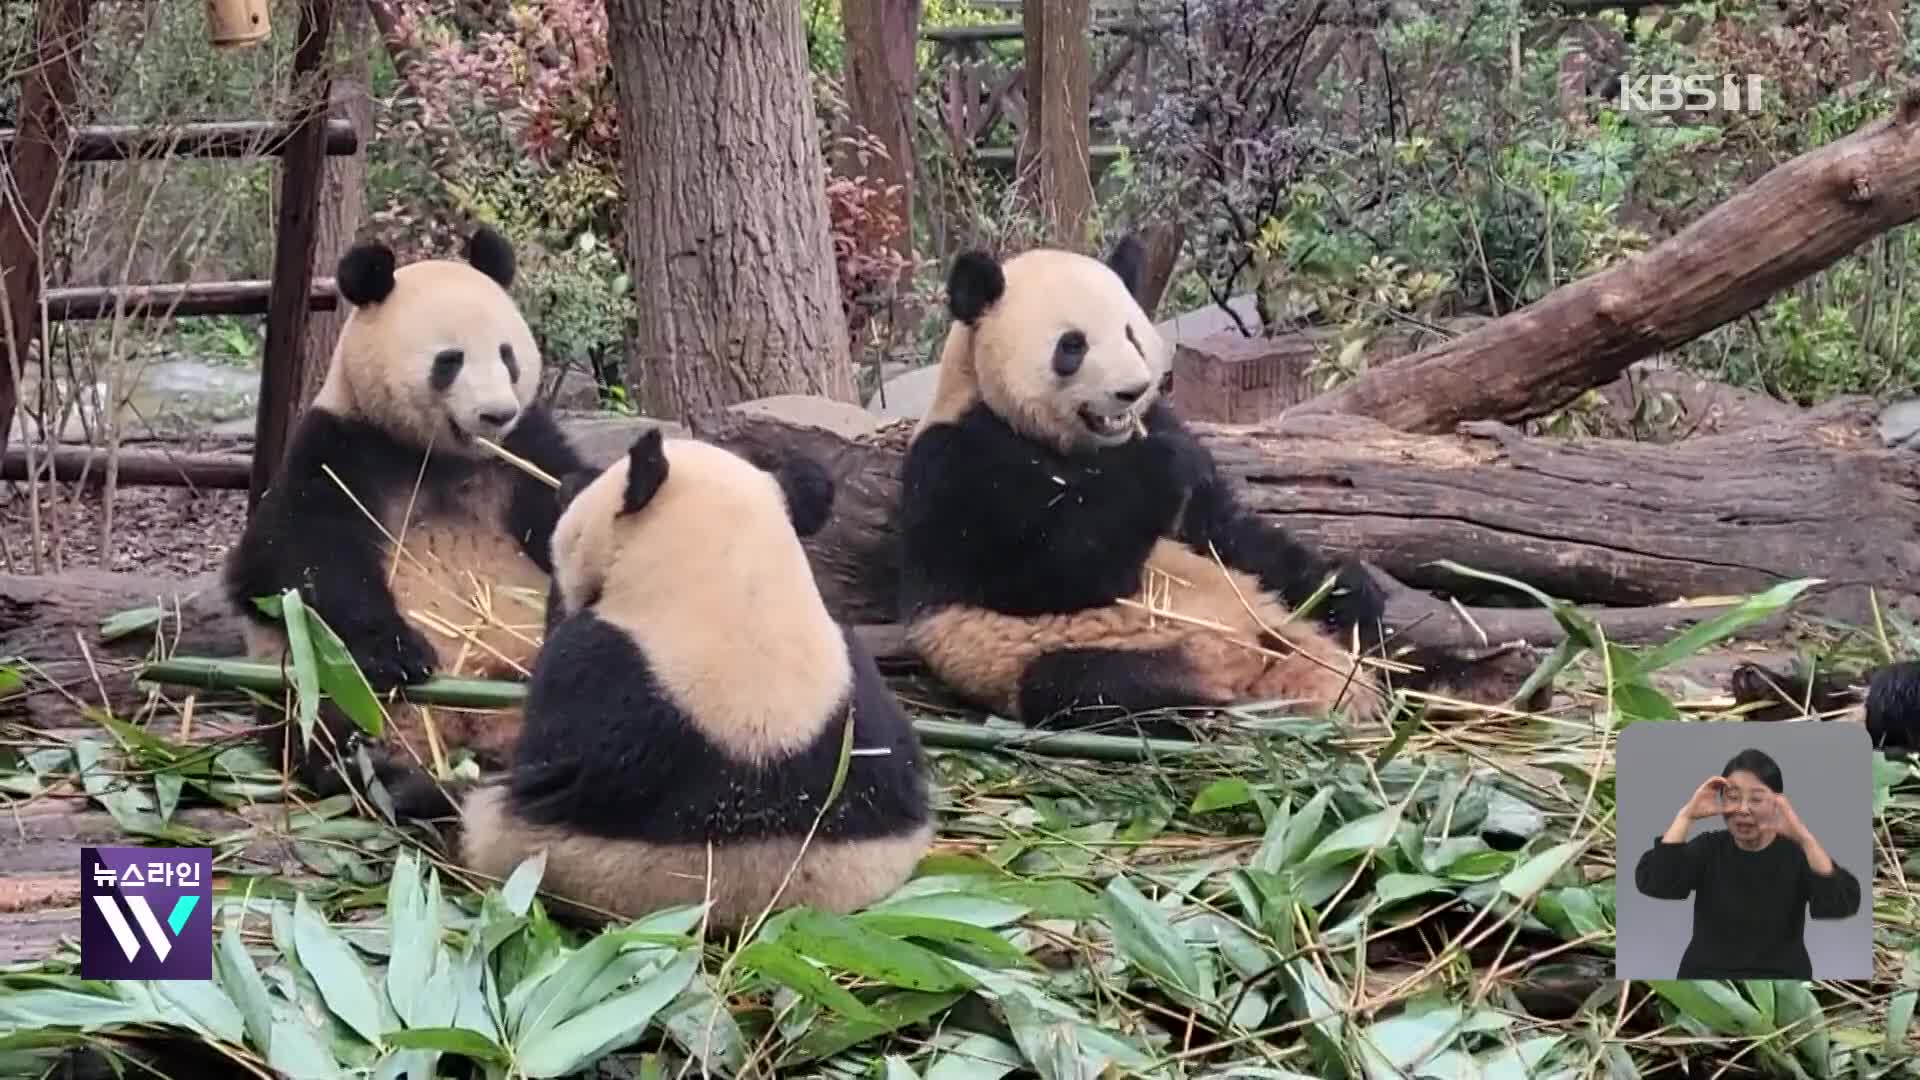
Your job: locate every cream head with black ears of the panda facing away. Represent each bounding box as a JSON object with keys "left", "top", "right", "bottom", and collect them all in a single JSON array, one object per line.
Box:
[{"left": 553, "top": 429, "right": 833, "bottom": 625}]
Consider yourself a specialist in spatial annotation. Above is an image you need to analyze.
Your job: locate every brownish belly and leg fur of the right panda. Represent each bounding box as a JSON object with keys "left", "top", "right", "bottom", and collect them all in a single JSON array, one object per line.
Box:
[{"left": 908, "top": 540, "right": 1386, "bottom": 723}]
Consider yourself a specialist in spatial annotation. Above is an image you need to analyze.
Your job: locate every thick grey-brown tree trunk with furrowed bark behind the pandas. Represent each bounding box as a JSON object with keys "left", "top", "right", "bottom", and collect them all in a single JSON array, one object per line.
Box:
[{"left": 607, "top": 0, "right": 854, "bottom": 417}]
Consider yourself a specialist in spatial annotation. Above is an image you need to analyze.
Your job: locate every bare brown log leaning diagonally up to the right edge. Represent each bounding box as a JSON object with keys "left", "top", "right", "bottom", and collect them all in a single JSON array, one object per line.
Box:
[{"left": 1288, "top": 90, "right": 1920, "bottom": 432}]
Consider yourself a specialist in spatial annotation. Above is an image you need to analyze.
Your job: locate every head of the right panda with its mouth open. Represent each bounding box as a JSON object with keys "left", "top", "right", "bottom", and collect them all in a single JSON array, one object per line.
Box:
[{"left": 922, "top": 236, "right": 1173, "bottom": 454}]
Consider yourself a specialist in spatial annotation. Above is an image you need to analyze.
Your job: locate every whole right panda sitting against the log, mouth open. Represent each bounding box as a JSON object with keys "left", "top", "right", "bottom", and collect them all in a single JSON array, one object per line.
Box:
[{"left": 899, "top": 238, "right": 1549, "bottom": 730}]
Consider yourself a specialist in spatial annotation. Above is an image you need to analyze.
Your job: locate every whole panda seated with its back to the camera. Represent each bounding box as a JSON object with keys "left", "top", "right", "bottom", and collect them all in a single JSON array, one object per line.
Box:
[{"left": 461, "top": 429, "right": 933, "bottom": 928}]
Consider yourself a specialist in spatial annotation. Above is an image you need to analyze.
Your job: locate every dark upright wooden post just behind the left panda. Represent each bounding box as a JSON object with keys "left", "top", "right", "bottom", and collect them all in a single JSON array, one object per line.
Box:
[{"left": 248, "top": 0, "right": 334, "bottom": 511}]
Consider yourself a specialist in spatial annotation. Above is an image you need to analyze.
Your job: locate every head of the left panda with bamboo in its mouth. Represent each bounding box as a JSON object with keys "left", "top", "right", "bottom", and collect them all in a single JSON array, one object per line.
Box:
[{"left": 315, "top": 227, "right": 540, "bottom": 455}]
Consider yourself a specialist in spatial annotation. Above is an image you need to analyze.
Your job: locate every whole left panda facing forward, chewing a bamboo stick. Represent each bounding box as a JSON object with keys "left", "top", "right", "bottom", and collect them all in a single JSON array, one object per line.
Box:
[{"left": 225, "top": 227, "right": 586, "bottom": 817}]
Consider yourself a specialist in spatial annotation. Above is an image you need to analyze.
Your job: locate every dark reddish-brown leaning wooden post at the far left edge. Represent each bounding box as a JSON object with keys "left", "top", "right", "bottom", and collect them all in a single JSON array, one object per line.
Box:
[{"left": 0, "top": 0, "right": 92, "bottom": 463}]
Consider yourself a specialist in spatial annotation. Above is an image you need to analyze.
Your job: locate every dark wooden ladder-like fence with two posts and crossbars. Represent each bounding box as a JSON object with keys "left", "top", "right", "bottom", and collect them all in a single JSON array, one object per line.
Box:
[{"left": 0, "top": 0, "right": 345, "bottom": 509}]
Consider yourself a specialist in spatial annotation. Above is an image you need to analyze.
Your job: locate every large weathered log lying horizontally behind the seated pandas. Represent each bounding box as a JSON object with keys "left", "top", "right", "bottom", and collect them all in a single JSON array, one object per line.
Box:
[{"left": 11, "top": 400, "right": 1920, "bottom": 717}]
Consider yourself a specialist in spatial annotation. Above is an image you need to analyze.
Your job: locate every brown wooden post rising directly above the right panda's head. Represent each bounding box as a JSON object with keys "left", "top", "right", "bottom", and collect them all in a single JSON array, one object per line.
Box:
[{"left": 1020, "top": 0, "right": 1092, "bottom": 250}]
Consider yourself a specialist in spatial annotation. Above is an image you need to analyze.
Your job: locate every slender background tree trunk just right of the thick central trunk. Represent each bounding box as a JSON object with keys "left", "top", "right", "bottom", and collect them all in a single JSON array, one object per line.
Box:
[{"left": 841, "top": 0, "right": 920, "bottom": 265}]
